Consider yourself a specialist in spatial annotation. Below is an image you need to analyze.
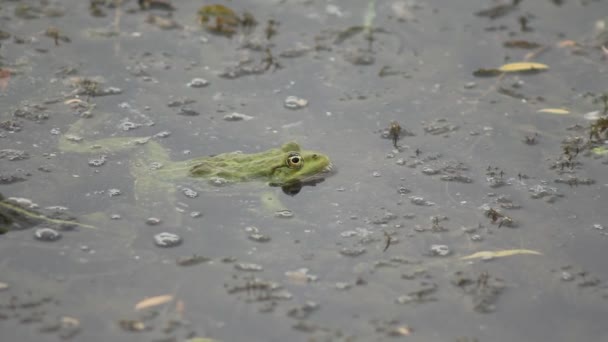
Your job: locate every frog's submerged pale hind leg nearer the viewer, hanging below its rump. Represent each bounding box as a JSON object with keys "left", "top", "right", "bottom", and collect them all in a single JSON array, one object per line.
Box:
[{"left": 130, "top": 141, "right": 181, "bottom": 226}]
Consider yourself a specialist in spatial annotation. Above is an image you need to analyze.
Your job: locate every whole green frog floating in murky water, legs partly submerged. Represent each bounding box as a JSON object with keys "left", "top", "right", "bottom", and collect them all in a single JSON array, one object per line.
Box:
[{"left": 58, "top": 115, "right": 334, "bottom": 222}]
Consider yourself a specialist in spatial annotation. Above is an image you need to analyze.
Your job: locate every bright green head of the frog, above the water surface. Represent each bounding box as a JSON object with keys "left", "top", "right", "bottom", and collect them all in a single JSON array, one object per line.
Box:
[{"left": 270, "top": 142, "right": 332, "bottom": 186}]
